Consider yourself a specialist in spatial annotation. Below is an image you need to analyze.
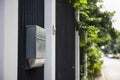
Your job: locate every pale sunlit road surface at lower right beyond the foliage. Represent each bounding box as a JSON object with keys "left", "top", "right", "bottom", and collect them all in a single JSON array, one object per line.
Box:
[{"left": 103, "top": 58, "right": 120, "bottom": 80}]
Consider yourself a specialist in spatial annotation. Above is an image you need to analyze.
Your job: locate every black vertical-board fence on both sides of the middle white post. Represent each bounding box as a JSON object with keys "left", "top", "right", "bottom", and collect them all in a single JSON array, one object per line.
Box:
[{"left": 18, "top": 0, "right": 75, "bottom": 80}]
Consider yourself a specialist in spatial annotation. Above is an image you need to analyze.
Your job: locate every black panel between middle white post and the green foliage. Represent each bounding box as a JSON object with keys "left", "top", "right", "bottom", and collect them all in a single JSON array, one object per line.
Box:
[{"left": 56, "top": 0, "right": 75, "bottom": 80}]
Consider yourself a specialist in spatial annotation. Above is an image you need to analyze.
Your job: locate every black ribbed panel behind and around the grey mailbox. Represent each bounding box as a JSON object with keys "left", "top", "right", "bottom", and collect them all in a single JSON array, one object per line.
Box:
[{"left": 18, "top": 0, "right": 44, "bottom": 80}]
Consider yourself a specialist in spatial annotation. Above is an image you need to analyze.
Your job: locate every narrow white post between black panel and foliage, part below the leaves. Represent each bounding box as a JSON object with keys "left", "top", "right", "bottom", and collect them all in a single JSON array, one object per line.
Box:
[{"left": 75, "top": 30, "right": 80, "bottom": 80}]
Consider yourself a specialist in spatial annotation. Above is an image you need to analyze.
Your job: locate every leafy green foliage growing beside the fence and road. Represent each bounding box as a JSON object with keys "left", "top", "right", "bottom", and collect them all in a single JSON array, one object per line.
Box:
[{"left": 69, "top": 0, "right": 117, "bottom": 80}]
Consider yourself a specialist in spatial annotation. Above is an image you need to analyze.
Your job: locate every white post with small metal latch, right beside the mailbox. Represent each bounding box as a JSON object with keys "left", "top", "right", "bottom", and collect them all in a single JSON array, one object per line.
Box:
[{"left": 44, "top": 0, "right": 55, "bottom": 80}]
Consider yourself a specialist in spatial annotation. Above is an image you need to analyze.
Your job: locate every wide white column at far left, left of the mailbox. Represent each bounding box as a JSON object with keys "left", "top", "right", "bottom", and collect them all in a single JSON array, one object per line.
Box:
[{"left": 3, "top": 0, "right": 18, "bottom": 80}]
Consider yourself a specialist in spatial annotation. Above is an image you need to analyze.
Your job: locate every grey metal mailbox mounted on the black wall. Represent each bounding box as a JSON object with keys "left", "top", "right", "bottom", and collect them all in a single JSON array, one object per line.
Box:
[{"left": 26, "top": 25, "right": 46, "bottom": 69}]
